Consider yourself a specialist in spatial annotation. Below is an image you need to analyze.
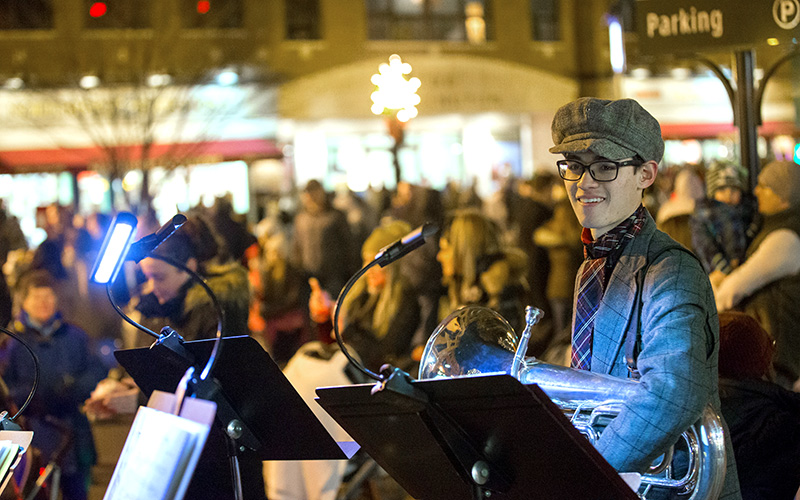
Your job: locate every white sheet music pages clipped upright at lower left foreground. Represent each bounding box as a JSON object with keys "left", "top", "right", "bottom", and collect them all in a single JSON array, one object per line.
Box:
[{"left": 103, "top": 407, "right": 209, "bottom": 500}]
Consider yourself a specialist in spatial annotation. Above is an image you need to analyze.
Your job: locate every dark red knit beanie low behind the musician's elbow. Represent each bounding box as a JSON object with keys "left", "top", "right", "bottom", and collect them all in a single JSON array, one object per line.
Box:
[{"left": 719, "top": 311, "right": 775, "bottom": 379}]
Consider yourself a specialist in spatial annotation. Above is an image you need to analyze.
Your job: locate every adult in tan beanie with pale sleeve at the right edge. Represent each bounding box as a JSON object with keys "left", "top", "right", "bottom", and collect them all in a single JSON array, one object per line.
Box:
[{"left": 715, "top": 161, "right": 800, "bottom": 388}]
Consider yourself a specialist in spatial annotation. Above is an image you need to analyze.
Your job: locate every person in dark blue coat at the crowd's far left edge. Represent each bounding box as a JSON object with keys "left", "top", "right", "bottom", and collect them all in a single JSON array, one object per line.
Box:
[{"left": 3, "top": 269, "right": 106, "bottom": 500}]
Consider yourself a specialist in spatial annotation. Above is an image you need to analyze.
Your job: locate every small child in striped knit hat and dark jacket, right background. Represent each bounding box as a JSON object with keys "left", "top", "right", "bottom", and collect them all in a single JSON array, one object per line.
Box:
[{"left": 689, "top": 160, "right": 760, "bottom": 285}]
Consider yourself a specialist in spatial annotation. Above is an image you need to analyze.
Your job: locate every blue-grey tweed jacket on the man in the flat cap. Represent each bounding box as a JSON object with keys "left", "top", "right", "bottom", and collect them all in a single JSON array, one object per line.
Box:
[{"left": 573, "top": 214, "right": 741, "bottom": 499}]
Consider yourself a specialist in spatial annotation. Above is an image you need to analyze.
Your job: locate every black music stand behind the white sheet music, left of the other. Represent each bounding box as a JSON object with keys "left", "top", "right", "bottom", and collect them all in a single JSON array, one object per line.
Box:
[{"left": 114, "top": 336, "right": 358, "bottom": 460}]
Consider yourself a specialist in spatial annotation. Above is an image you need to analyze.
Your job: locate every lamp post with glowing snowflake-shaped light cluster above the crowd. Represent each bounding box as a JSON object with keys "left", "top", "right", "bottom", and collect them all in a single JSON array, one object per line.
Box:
[{"left": 371, "top": 54, "right": 421, "bottom": 187}]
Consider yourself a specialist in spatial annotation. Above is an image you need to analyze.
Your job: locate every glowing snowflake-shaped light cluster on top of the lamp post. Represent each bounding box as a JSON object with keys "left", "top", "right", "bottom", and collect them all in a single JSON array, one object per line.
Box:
[{"left": 371, "top": 54, "right": 421, "bottom": 123}]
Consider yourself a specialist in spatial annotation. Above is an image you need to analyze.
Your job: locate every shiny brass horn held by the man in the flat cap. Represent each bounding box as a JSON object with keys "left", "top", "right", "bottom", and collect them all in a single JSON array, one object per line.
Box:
[{"left": 418, "top": 306, "right": 725, "bottom": 500}]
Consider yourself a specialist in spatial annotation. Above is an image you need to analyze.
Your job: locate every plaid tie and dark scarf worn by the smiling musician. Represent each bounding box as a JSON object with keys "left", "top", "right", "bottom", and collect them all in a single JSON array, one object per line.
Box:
[{"left": 572, "top": 205, "right": 647, "bottom": 370}]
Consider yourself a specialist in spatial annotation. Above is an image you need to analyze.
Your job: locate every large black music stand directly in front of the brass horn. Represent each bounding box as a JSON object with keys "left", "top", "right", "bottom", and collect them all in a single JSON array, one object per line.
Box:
[{"left": 317, "top": 375, "right": 638, "bottom": 500}]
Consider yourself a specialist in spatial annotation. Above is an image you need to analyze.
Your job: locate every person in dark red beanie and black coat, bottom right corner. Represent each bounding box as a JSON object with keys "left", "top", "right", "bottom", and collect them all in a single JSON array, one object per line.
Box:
[{"left": 719, "top": 311, "right": 800, "bottom": 499}]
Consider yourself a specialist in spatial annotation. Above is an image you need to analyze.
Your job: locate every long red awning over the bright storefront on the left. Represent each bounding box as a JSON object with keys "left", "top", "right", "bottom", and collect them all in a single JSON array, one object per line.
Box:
[{"left": 0, "top": 139, "right": 283, "bottom": 173}]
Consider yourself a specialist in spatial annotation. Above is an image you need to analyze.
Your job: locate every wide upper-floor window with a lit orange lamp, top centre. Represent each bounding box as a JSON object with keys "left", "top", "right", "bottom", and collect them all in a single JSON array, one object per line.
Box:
[{"left": 366, "top": 0, "right": 492, "bottom": 41}]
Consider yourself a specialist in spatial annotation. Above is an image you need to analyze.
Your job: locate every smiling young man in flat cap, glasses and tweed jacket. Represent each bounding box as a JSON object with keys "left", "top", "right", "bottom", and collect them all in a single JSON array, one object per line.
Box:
[{"left": 550, "top": 98, "right": 741, "bottom": 499}]
